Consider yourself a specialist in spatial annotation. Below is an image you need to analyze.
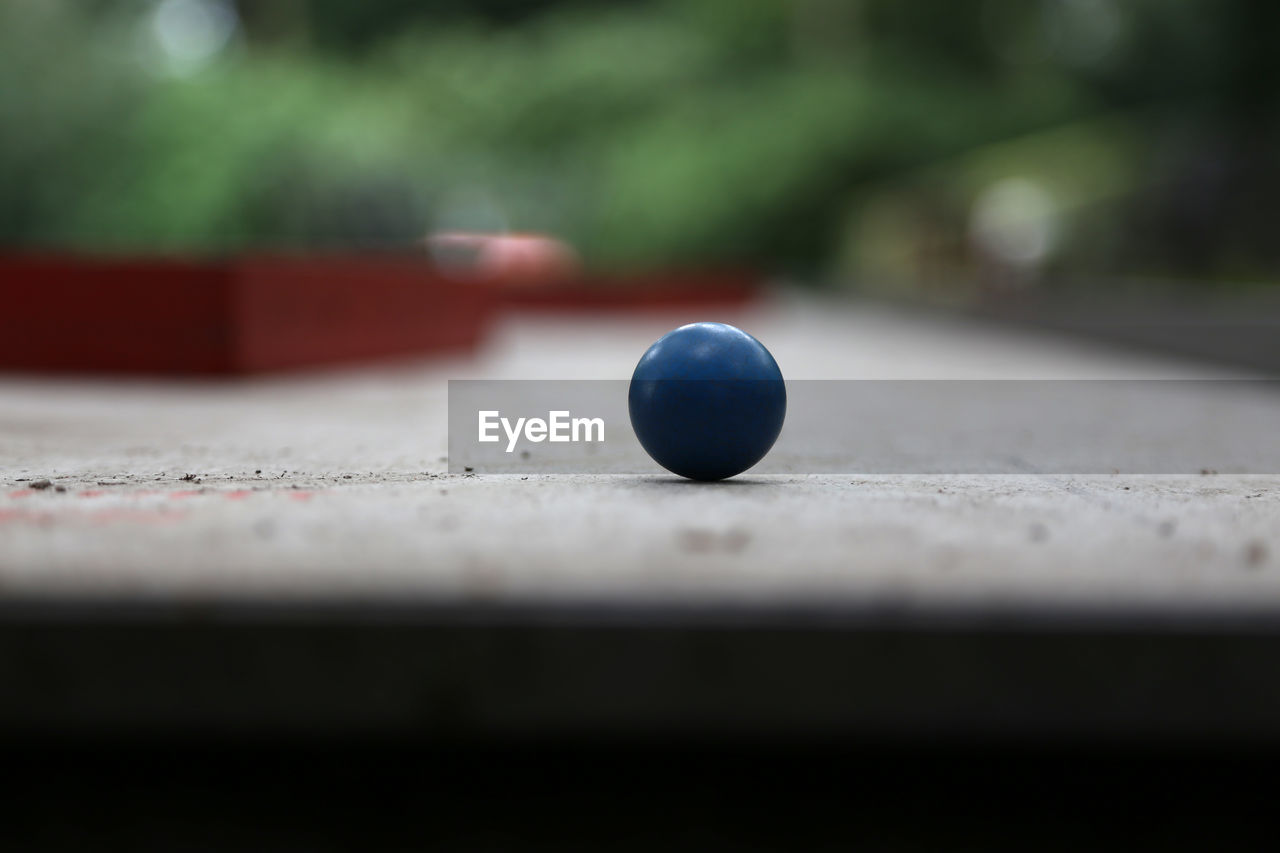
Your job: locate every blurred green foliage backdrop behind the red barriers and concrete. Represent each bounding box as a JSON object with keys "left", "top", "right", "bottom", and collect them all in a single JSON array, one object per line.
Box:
[{"left": 0, "top": 0, "right": 1280, "bottom": 301}]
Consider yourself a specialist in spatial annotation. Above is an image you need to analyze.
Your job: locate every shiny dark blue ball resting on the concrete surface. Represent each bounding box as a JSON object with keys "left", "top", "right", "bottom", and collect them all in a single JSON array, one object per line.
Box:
[{"left": 627, "top": 323, "right": 787, "bottom": 480}]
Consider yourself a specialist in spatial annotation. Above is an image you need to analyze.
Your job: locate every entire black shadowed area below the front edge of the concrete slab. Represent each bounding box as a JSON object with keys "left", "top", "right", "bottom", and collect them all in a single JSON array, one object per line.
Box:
[{"left": 0, "top": 603, "right": 1280, "bottom": 853}]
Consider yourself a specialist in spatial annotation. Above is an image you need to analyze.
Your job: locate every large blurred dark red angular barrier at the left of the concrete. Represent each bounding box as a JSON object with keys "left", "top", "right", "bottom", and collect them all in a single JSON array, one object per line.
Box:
[{"left": 0, "top": 255, "right": 497, "bottom": 374}]
